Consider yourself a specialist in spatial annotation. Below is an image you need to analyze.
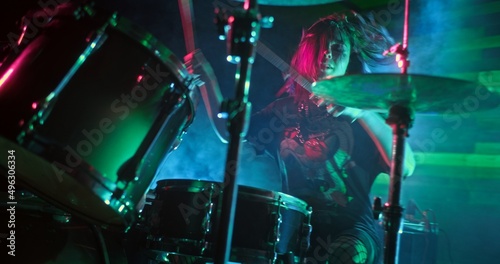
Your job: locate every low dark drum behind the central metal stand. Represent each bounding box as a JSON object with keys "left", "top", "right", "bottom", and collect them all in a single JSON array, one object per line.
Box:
[{"left": 140, "top": 180, "right": 312, "bottom": 263}]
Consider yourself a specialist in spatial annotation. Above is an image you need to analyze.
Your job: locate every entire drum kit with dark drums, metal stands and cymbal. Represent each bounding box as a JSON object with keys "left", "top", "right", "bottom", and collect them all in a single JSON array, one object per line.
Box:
[{"left": 0, "top": 0, "right": 498, "bottom": 263}]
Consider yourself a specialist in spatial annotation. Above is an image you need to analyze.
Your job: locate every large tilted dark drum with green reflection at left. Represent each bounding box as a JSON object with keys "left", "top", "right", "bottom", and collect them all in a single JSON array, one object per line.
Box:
[{"left": 0, "top": 2, "right": 198, "bottom": 229}]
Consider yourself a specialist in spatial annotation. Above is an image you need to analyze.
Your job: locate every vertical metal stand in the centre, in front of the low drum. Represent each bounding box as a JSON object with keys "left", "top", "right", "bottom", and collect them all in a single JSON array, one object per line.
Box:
[{"left": 214, "top": 0, "right": 260, "bottom": 264}]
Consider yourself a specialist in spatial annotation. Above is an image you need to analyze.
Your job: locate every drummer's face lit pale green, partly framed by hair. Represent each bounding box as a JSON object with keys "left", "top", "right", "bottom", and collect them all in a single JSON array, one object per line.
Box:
[{"left": 319, "top": 32, "right": 351, "bottom": 79}]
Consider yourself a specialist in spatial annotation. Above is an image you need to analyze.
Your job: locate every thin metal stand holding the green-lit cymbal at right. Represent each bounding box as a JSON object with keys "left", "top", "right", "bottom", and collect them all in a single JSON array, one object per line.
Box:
[{"left": 383, "top": 0, "right": 414, "bottom": 264}]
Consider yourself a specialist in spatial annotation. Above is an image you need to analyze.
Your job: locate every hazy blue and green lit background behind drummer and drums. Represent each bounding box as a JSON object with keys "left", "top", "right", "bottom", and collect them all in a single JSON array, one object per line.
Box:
[{"left": 0, "top": 0, "right": 500, "bottom": 264}]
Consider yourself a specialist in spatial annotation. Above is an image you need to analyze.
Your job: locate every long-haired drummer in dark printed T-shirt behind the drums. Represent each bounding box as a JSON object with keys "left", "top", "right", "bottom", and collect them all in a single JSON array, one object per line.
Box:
[{"left": 248, "top": 12, "right": 415, "bottom": 264}]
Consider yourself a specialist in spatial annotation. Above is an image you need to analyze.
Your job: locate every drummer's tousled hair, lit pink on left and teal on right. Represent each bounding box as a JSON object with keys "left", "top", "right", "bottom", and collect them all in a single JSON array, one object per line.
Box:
[{"left": 280, "top": 11, "right": 394, "bottom": 101}]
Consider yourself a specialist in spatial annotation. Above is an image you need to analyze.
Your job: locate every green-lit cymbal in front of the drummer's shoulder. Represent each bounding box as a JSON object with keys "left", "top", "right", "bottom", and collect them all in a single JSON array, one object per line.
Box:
[{"left": 312, "top": 73, "right": 500, "bottom": 114}]
